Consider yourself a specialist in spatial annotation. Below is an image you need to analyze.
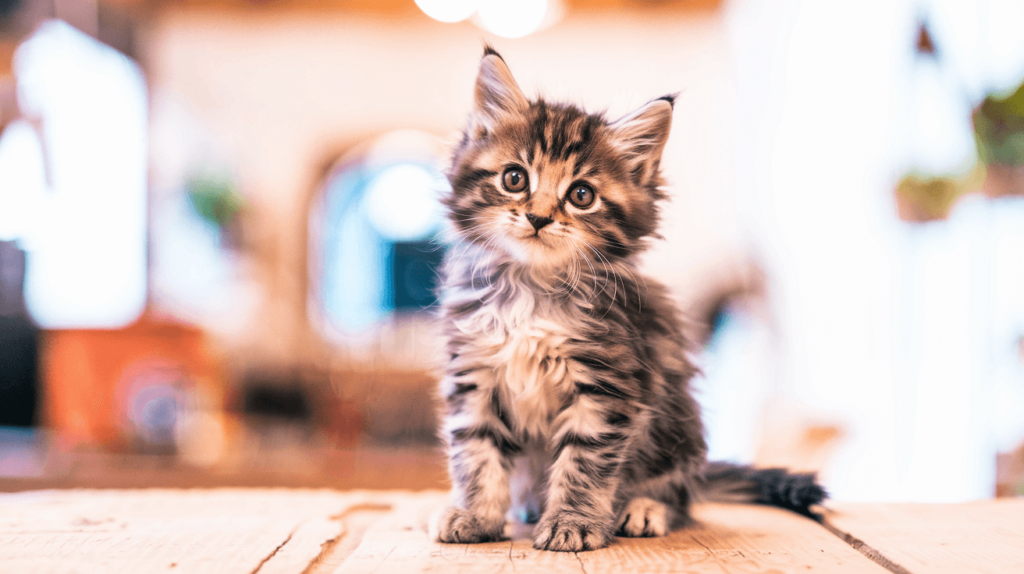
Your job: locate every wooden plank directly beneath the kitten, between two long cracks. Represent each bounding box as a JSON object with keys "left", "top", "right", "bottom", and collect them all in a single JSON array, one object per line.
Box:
[{"left": 336, "top": 494, "right": 886, "bottom": 574}]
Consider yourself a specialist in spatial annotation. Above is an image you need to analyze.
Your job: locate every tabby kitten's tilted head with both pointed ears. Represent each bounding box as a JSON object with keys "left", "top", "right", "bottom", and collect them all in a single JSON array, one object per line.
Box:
[{"left": 445, "top": 47, "right": 674, "bottom": 267}]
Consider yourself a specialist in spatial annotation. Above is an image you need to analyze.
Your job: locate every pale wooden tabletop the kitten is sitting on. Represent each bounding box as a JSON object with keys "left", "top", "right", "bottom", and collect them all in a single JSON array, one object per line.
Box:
[{"left": 0, "top": 488, "right": 1024, "bottom": 574}]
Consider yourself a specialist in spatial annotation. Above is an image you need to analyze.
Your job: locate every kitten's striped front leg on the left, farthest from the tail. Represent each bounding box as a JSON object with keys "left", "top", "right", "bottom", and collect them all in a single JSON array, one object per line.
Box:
[{"left": 430, "top": 370, "right": 520, "bottom": 542}]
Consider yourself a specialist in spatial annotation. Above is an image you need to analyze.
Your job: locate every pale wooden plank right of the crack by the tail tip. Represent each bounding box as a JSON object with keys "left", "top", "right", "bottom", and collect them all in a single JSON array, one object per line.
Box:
[{"left": 826, "top": 498, "right": 1024, "bottom": 574}]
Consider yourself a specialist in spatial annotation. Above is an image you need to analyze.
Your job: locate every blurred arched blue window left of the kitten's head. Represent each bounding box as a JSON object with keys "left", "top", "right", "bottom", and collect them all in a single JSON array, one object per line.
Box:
[{"left": 310, "top": 131, "right": 447, "bottom": 354}]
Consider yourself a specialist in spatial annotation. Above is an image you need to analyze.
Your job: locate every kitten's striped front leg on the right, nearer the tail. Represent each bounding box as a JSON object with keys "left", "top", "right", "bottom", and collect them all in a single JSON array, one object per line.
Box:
[{"left": 534, "top": 384, "right": 633, "bottom": 551}]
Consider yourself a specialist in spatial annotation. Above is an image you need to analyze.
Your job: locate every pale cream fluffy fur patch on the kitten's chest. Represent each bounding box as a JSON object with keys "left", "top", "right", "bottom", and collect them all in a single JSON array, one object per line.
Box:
[{"left": 456, "top": 290, "right": 571, "bottom": 436}]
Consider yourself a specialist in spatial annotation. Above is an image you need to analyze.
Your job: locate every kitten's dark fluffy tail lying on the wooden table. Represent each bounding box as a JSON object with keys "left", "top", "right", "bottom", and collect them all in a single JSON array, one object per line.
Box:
[{"left": 694, "top": 462, "right": 828, "bottom": 521}]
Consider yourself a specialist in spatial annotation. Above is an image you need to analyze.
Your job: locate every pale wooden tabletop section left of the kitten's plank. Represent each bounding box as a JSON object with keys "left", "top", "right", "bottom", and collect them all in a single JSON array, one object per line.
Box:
[{"left": 0, "top": 489, "right": 364, "bottom": 574}]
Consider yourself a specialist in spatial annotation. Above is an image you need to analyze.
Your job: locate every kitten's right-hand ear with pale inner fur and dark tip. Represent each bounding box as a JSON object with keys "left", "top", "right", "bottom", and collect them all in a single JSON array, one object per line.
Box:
[{"left": 608, "top": 94, "right": 676, "bottom": 183}]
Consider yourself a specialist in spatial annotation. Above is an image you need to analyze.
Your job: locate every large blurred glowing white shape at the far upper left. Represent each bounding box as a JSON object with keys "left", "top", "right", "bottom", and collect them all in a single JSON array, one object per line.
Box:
[{"left": 8, "top": 20, "right": 148, "bottom": 328}]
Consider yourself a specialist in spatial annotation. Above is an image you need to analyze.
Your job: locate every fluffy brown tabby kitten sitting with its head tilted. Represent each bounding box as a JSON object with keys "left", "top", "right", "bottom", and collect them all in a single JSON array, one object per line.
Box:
[{"left": 431, "top": 47, "right": 824, "bottom": 551}]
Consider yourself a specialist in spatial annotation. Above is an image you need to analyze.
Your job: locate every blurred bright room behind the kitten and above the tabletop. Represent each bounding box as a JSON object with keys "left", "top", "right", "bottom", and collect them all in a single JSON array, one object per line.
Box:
[{"left": 0, "top": 0, "right": 1024, "bottom": 502}]
